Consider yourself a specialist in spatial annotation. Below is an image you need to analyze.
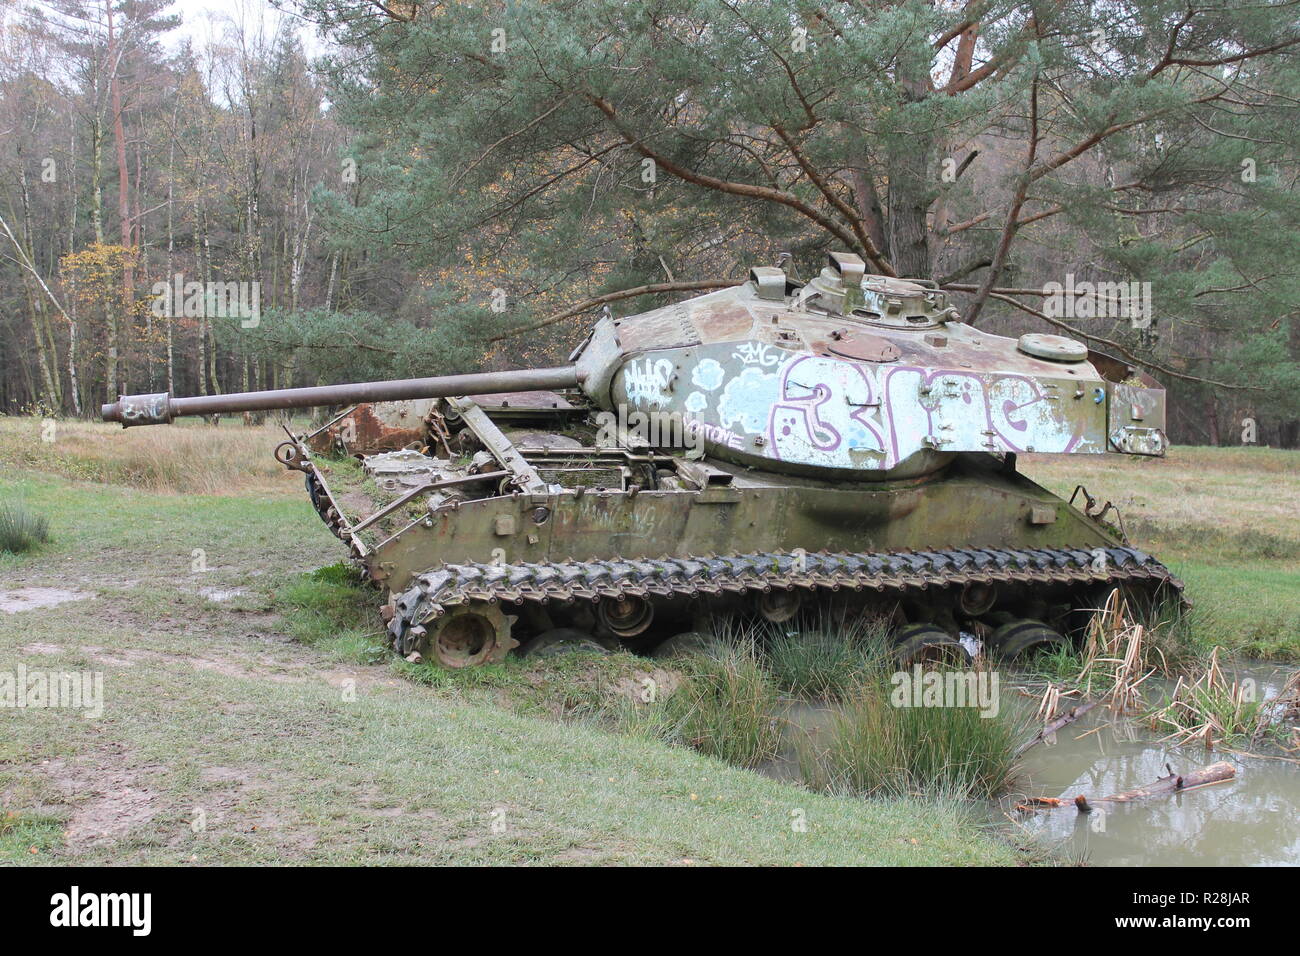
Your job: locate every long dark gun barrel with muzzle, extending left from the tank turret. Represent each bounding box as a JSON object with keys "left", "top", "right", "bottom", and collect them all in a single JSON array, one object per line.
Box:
[{"left": 100, "top": 365, "right": 582, "bottom": 428}]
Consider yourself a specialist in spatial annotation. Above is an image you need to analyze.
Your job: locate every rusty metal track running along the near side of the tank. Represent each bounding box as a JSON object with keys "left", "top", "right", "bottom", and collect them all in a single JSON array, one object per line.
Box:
[{"left": 389, "top": 548, "right": 1183, "bottom": 656}]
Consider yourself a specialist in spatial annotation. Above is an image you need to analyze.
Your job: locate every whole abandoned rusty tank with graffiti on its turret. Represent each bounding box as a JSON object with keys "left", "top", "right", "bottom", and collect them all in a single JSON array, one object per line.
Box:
[{"left": 103, "top": 254, "right": 1182, "bottom": 667}]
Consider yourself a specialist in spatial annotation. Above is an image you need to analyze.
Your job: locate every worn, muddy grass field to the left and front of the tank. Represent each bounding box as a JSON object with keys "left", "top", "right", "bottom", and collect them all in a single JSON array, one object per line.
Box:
[{"left": 0, "top": 419, "right": 1026, "bottom": 865}]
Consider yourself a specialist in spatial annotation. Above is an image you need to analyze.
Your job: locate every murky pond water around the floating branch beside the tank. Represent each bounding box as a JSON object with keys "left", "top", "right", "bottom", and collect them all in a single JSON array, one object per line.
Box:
[{"left": 763, "top": 665, "right": 1300, "bottom": 866}]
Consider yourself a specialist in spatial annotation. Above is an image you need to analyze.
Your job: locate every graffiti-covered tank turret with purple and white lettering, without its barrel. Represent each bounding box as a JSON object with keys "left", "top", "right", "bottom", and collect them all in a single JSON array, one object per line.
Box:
[{"left": 577, "top": 254, "right": 1165, "bottom": 480}]
